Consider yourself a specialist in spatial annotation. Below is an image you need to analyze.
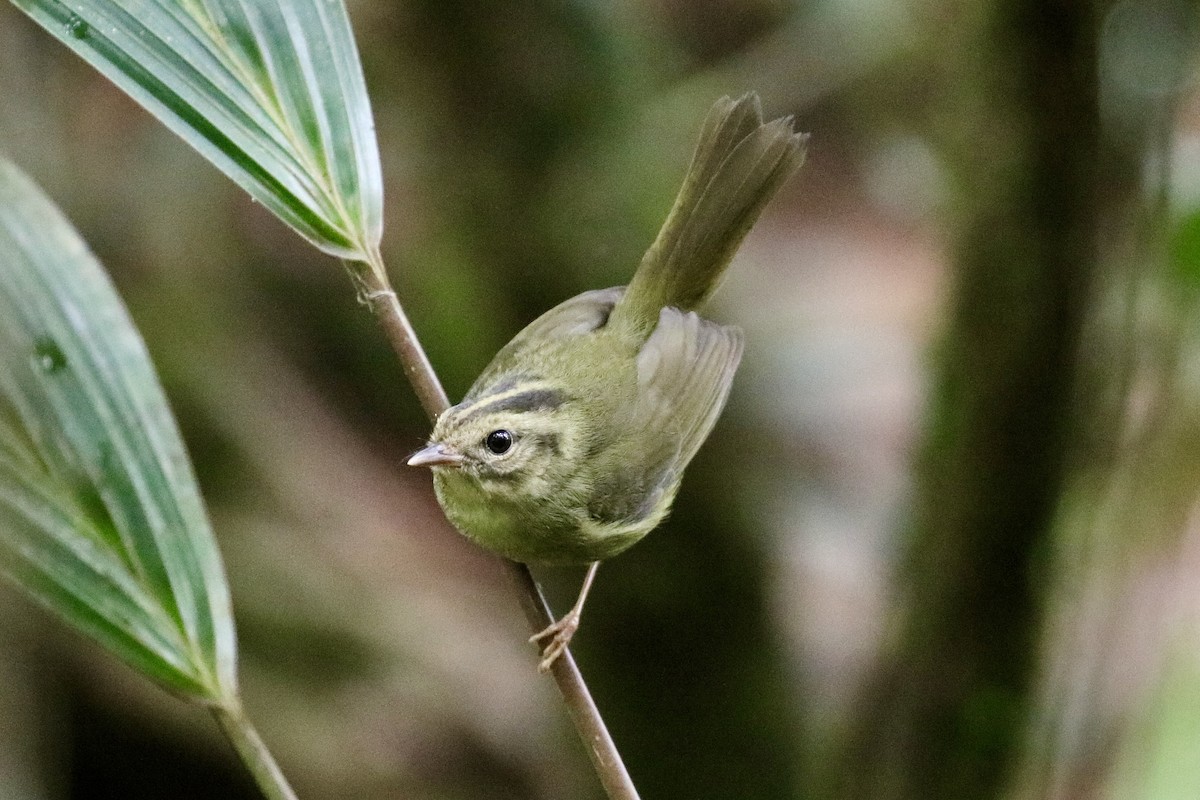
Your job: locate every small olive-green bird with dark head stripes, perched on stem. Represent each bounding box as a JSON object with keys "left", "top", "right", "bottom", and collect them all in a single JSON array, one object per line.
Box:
[{"left": 408, "top": 95, "right": 805, "bottom": 672}]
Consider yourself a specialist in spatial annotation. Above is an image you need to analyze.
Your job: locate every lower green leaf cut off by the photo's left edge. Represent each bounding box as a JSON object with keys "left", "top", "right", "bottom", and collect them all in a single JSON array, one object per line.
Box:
[{"left": 0, "top": 160, "right": 236, "bottom": 704}]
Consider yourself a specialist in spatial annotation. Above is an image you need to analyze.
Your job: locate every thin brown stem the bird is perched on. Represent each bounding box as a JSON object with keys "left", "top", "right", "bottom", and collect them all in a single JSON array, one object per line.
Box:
[{"left": 346, "top": 261, "right": 638, "bottom": 800}]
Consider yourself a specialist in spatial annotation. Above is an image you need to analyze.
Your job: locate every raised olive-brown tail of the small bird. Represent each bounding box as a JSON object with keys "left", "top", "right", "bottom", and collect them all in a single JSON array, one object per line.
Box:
[{"left": 611, "top": 94, "right": 808, "bottom": 333}]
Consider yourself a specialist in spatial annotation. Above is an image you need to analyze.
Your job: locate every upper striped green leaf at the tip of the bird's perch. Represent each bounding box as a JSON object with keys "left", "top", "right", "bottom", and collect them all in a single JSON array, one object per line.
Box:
[{"left": 13, "top": 0, "right": 383, "bottom": 264}]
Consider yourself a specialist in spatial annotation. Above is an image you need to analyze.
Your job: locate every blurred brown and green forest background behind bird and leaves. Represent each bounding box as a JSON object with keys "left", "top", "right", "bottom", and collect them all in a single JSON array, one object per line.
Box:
[{"left": 0, "top": 0, "right": 1200, "bottom": 800}]
